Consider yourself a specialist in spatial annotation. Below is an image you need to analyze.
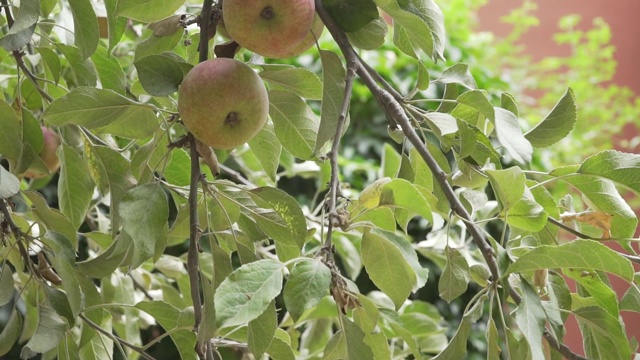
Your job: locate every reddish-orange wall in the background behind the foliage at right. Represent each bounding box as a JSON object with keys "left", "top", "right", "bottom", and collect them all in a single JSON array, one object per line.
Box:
[{"left": 479, "top": 0, "right": 640, "bottom": 354}]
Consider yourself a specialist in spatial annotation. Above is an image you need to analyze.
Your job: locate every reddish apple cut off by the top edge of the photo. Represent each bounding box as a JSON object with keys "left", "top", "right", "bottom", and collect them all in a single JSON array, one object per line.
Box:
[{"left": 222, "top": 0, "right": 315, "bottom": 59}]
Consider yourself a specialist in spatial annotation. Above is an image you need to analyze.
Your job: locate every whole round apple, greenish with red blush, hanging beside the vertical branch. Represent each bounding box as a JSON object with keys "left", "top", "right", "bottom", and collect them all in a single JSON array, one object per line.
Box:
[{"left": 178, "top": 58, "right": 269, "bottom": 150}]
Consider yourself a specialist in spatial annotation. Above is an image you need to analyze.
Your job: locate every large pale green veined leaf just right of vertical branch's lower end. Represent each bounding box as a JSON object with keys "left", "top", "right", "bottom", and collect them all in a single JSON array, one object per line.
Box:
[{"left": 214, "top": 259, "right": 284, "bottom": 327}]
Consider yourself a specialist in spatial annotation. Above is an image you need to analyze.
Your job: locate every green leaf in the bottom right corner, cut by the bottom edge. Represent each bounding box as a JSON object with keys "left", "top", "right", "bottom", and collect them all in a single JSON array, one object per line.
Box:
[{"left": 573, "top": 306, "right": 632, "bottom": 360}]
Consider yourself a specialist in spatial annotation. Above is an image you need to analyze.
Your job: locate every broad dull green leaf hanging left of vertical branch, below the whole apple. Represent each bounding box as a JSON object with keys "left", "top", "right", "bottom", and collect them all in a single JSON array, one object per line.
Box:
[{"left": 116, "top": 183, "right": 169, "bottom": 269}]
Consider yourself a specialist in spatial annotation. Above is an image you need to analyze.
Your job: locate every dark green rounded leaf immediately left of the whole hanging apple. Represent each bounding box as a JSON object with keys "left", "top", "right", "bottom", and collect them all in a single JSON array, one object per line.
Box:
[{"left": 133, "top": 55, "right": 183, "bottom": 96}]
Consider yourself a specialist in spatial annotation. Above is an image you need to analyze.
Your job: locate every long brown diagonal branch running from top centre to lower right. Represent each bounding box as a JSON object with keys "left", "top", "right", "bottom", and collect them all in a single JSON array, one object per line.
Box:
[{"left": 315, "top": 0, "right": 586, "bottom": 360}]
